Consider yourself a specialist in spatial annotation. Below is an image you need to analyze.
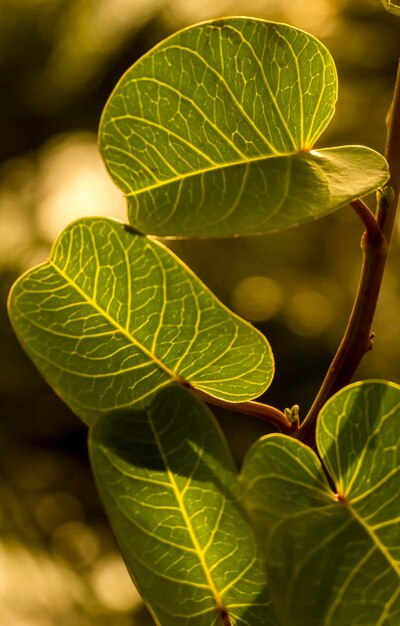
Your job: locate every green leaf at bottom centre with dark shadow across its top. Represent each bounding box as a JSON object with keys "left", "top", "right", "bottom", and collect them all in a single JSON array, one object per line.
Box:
[{"left": 90, "top": 386, "right": 276, "bottom": 626}]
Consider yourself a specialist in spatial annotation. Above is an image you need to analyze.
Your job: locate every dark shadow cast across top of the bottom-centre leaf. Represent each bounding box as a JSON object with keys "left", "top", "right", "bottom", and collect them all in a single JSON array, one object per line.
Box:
[{"left": 91, "top": 383, "right": 253, "bottom": 515}]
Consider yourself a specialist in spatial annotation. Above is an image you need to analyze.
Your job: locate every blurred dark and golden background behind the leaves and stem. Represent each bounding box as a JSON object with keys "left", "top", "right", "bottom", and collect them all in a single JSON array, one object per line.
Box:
[{"left": 0, "top": 0, "right": 400, "bottom": 626}]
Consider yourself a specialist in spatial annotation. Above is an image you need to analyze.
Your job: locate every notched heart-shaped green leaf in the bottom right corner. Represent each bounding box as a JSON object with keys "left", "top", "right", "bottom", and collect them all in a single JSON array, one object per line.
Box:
[{"left": 244, "top": 381, "right": 400, "bottom": 626}]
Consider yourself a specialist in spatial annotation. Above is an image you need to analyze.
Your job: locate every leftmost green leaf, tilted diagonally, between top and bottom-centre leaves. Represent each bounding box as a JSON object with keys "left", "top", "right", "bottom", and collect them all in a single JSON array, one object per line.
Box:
[{"left": 10, "top": 218, "right": 273, "bottom": 421}]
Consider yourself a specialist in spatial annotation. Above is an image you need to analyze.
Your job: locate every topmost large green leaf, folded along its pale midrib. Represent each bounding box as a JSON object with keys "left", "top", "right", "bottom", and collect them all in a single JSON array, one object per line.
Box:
[{"left": 100, "top": 18, "right": 388, "bottom": 237}]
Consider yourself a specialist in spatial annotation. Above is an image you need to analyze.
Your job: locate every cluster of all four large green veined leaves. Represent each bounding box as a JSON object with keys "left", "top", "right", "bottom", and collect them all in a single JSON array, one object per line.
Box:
[{"left": 10, "top": 18, "right": 400, "bottom": 626}]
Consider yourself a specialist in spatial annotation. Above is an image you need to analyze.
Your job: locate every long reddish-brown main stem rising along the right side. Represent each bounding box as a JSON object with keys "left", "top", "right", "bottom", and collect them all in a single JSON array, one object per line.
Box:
[{"left": 295, "top": 59, "right": 400, "bottom": 447}]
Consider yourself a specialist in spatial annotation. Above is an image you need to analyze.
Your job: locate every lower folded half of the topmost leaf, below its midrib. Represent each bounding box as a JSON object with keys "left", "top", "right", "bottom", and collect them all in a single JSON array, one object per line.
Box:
[{"left": 127, "top": 146, "right": 387, "bottom": 237}]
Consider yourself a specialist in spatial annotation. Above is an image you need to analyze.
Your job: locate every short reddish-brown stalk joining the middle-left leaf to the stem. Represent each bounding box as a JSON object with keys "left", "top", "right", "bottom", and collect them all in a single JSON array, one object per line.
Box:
[{"left": 189, "top": 386, "right": 298, "bottom": 435}]
